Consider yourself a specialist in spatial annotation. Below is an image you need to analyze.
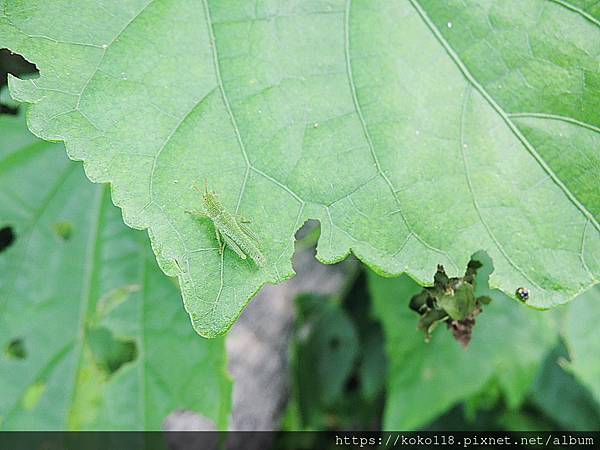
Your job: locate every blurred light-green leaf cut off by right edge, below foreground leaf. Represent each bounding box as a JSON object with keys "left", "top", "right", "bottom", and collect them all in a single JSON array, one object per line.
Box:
[{"left": 563, "top": 287, "right": 600, "bottom": 405}]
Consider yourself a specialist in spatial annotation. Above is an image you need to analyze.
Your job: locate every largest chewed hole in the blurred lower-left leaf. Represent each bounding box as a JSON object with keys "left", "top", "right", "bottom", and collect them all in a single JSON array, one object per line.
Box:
[{"left": 89, "top": 327, "right": 138, "bottom": 375}]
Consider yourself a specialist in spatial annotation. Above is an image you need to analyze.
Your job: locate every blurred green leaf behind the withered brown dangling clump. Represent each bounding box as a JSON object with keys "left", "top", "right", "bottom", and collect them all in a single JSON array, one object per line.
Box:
[{"left": 369, "top": 262, "right": 557, "bottom": 430}]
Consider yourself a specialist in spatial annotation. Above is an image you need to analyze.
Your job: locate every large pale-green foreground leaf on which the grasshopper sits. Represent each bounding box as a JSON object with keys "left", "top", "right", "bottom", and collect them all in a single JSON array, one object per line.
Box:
[{"left": 0, "top": 0, "right": 600, "bottom": 336}]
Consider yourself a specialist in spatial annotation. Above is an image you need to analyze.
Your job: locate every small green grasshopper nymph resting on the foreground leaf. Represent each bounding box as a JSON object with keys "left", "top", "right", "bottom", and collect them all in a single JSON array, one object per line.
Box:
[{"left": 186, "top": 180, "right": 267, "bottom": 267}]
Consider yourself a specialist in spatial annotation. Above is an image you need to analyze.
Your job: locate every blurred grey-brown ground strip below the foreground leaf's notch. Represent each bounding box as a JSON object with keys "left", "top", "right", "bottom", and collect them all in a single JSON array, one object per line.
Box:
[{"left": 227, "top": 249, "right": 355, "bottom": 431}]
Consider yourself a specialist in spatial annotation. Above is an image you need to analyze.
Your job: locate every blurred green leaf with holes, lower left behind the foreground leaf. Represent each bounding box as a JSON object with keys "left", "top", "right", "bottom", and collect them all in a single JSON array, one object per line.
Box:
[{"left": 0, "top": 109, "right": 231, "bottom": 430}]
